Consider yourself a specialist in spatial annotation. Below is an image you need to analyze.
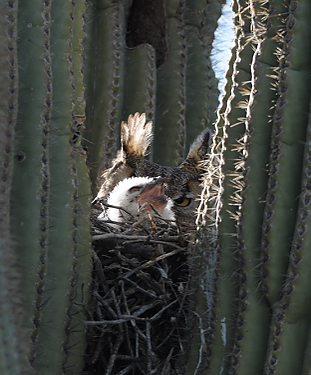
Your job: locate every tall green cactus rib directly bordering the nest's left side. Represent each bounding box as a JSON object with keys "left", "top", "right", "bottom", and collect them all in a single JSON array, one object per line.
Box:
[{"left": 36, "top": 1, "right": 90, "bottom": 374}]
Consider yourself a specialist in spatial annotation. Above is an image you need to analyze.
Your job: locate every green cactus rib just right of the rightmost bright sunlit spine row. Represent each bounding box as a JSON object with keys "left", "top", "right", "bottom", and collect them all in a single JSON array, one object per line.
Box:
[{"left": 231, "top": 0, "right": 286, "bottom": 374}]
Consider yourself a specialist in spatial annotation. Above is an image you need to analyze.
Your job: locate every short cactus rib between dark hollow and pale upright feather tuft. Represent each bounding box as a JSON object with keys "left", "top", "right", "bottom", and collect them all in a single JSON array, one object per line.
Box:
[{"left": 123, "top": 44, "right": 156, "bottom": 121}]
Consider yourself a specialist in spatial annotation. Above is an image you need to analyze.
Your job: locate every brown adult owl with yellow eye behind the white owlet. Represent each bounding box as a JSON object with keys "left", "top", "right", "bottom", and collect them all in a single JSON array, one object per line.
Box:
[{"left": 95, "top": 113, "right": 211, "bottom": 224}]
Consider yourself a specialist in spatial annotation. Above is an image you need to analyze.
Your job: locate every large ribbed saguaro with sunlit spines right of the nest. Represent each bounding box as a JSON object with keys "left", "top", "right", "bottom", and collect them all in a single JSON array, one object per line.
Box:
[{"left": 197, "top": 0, "right": 311, "bottom": 374}]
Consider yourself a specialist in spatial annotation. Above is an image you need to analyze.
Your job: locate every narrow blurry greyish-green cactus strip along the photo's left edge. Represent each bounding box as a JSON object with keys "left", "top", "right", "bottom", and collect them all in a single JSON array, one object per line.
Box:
[{"left": 0, "top": 1, "right": 28, "bottom": 375}]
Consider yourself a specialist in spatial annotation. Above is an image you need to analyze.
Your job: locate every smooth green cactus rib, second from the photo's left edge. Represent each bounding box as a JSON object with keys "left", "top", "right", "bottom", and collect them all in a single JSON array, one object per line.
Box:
[{"left": 10, "top": 1, "right": 52, "bottom": 365}]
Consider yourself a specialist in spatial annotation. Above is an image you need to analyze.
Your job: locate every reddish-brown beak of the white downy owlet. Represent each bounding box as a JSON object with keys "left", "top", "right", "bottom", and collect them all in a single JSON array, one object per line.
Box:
[{"left": 137, "top": 177, "right": 167, "bottom": 213}]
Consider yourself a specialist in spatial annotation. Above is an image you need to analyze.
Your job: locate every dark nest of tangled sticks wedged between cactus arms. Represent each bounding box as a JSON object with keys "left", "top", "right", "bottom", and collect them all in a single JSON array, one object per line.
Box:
[{"left": 85, "top": 206, "right": 194, "bottom": 375}]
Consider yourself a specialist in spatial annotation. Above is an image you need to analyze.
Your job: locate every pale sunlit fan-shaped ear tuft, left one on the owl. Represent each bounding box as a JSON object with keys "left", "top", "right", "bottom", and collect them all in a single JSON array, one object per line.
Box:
[{"left": 121, "top": 112, "right": 152, "bottom": 159}]
